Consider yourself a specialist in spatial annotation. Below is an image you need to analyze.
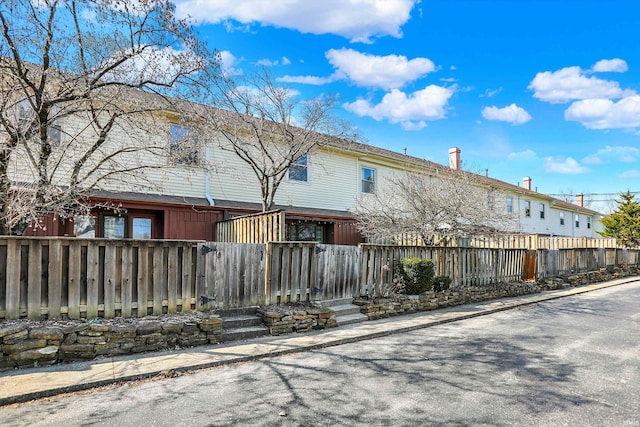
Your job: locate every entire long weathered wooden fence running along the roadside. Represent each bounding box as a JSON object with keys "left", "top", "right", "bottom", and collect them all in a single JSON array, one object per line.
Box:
[{"left": 0, "top": 237, "right": 640, "bottom": 319}]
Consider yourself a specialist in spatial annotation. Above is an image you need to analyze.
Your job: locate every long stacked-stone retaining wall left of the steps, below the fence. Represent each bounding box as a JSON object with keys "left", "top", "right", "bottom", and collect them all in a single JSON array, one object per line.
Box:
[{"left": 0, "top": 313, "right": 222, "bottom": 370}]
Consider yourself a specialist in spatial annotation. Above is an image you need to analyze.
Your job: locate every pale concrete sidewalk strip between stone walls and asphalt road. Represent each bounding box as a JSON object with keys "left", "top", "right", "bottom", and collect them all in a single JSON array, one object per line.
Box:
[{"left": 0, "top": 277, "right": 638, "bottom": 410}]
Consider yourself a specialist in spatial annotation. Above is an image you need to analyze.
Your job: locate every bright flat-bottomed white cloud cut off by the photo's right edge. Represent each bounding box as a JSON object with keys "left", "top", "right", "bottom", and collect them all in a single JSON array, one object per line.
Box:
[{"left": 564, "top": 95, "right": 640, "bottom": 129}]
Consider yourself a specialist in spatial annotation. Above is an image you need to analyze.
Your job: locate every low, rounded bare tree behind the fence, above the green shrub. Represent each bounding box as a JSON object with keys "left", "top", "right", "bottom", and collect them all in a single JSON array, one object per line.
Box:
[{"left": 354, "top": 170, "right": 517, "bottom": 244}]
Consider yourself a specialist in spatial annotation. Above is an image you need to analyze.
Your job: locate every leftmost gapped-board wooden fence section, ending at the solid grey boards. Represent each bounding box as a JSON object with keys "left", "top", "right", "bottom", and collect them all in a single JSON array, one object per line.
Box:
[{"left": 0, "top": 238, "right": 198, "bottom": 319}]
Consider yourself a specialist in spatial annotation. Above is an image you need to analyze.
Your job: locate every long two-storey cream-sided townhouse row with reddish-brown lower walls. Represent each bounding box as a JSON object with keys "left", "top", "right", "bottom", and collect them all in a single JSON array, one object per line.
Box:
[{"left": 16, "top": 93, "right": 601, "bottom": 245}]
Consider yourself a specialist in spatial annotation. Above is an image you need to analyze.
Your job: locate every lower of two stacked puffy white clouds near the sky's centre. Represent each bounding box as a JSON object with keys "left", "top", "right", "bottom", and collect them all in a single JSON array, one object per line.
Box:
[{"left": 344, "top": 85, "right": 454, "bottom": 129}]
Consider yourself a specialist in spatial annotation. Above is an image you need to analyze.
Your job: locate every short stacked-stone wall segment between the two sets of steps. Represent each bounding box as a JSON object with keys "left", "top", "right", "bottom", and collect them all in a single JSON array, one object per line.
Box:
[{"left": 258, "top": 306, "right": 338, "bottom": 335}]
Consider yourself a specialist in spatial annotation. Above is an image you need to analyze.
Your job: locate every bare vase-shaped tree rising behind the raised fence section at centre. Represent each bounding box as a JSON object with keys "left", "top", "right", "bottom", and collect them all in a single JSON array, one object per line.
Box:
[{"left": 194, "top": 69, "right": 356, "bottom": 211}]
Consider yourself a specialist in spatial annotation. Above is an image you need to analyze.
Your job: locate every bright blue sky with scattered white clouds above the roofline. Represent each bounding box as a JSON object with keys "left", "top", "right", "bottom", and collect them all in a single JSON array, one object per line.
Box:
[{"left": 175, "top": 0, "right": 640, "bottom": 214}]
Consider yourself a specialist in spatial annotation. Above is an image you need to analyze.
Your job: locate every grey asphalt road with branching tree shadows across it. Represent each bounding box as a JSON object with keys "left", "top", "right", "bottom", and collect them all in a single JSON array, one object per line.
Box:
[{"left": 0, "top": 282, "right": 640, "bottom": 427}]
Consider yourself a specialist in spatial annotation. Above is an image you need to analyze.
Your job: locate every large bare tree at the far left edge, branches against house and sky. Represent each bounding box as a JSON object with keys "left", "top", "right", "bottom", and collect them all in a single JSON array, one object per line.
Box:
[{"left": 0, "top": 0, "right": 217, "bottom": 234}]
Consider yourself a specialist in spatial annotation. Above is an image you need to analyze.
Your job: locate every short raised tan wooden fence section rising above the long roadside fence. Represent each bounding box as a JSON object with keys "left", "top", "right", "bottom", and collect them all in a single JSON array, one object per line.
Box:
[{"left": 216, "top": 210, "right": 285, "bottom": 243}]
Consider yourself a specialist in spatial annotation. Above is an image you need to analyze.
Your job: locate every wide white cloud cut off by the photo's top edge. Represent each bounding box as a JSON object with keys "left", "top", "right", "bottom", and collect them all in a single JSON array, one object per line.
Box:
[{"left": 174, "top": 0, "right": 419, "bottom": 42}]
